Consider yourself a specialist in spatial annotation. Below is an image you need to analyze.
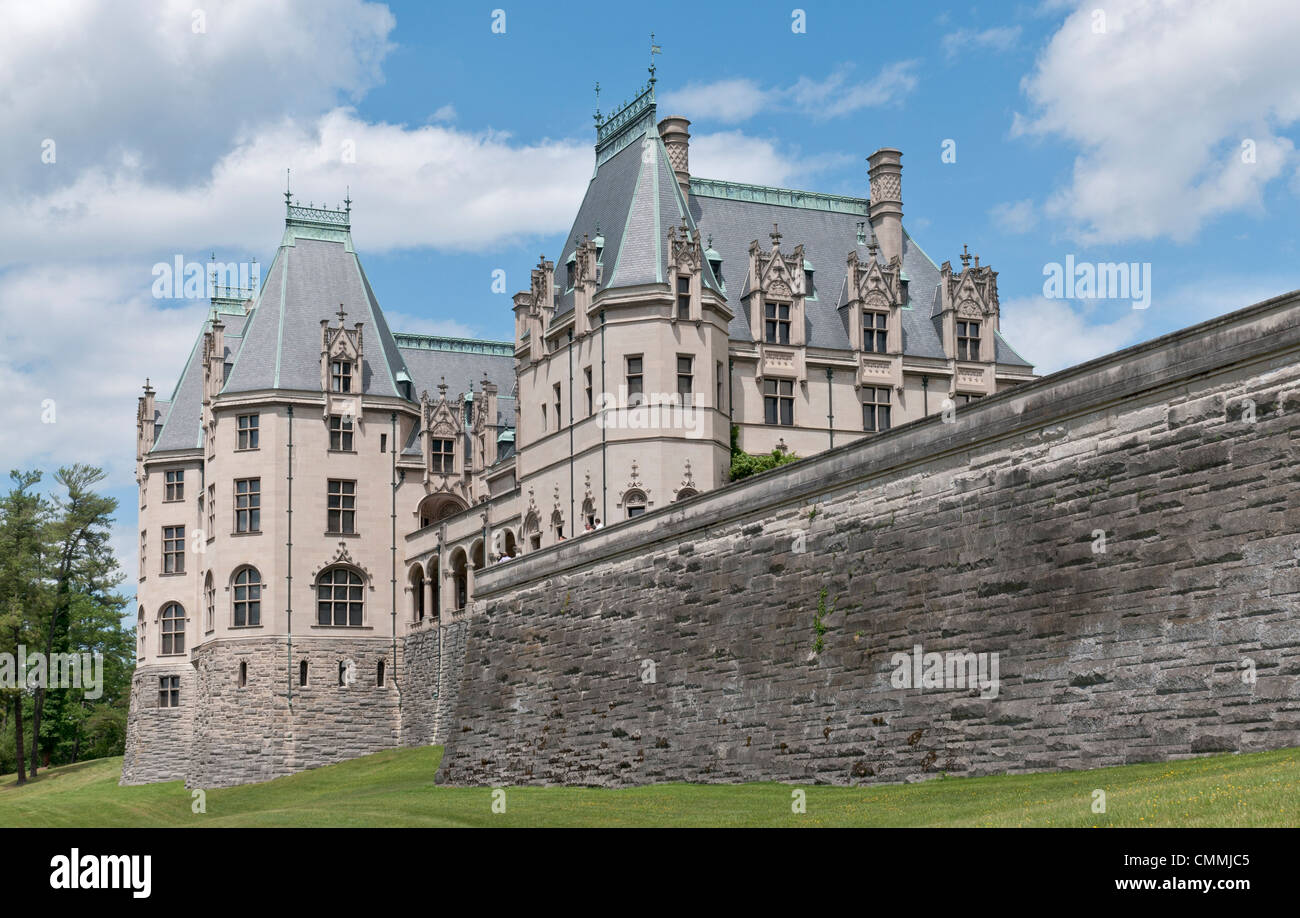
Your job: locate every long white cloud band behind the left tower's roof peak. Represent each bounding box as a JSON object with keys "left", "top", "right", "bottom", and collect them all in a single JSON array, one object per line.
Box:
[{"left": 0, "top": 109, "right": 592, "bottom": 270}]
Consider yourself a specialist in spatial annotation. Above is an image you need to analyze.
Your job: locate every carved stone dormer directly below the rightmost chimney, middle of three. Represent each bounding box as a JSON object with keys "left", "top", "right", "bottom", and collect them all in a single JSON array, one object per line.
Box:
[{"left": 841, "top": 242, "right": 906, "bottom": 391}]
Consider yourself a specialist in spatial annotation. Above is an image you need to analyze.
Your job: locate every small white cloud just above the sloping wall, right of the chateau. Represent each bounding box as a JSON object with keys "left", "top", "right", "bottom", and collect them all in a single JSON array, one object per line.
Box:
[{"left": 1000, "top": 296, "right": 1143, "bottom": 374}]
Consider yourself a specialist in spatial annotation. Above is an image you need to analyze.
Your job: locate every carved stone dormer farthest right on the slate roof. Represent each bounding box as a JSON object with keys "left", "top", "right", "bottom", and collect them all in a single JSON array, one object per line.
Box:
[{"left": 937, "top": 246, "right": 1000, "bottom": 394}]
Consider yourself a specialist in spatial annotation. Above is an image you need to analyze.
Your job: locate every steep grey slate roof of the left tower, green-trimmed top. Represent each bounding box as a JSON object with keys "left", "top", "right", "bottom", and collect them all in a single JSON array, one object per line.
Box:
[{"left": 222, "top": 202, "right": 408, "bottom": 398}]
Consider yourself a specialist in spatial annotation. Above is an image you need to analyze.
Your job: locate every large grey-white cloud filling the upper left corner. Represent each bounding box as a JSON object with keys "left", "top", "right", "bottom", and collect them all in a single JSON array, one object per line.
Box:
[{"left": 0, "top": 0, "right": 395, "bottom": 189}]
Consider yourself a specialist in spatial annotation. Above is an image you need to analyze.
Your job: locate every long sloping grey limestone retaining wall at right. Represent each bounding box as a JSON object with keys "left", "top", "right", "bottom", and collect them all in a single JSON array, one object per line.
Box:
[{"left": 439, "top": 289, "right": 1300, "bottom": 785}]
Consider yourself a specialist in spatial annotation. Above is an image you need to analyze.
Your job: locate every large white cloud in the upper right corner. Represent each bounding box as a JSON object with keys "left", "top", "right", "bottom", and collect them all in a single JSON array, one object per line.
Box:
[{"left": 1013, "top": 0, "right": 1300, "bottom": 243}]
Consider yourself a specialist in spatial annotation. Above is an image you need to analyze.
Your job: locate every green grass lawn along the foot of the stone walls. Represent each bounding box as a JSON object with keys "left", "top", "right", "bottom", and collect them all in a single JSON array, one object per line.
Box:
[{"left": 0, "top": 746, "right": 1300, "bottom": 827}]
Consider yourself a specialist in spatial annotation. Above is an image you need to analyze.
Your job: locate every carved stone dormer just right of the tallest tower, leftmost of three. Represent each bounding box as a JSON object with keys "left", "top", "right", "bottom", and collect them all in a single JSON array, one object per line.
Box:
[{"left": 745, "top": 224, "right": 807, "bottom": 384}]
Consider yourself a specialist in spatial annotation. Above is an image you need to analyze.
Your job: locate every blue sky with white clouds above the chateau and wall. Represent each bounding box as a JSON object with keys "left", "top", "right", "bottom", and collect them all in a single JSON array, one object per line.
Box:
[{"left": 0, "top": 0, "right": 1300, "bottom": 590}]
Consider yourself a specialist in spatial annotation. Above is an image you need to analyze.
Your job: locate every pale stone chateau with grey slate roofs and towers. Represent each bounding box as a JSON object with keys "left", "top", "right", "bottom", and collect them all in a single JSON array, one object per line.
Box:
[{"left": 122, "top": 79, "right": 1035, "bottom": 787}]
